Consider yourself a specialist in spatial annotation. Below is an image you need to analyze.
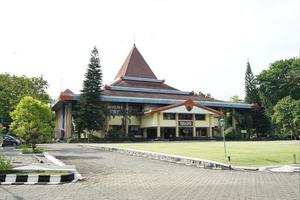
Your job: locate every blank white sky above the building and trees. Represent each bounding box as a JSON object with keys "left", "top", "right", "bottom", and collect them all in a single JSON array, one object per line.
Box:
[{"left": 0, "top": 0, "right": 300, "bottom": 100}]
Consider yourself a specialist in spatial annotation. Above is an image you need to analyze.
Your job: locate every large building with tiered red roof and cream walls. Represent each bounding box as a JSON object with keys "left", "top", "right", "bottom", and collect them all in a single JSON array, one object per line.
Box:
[{"left": 52, "top": 45, "right": 252, "bottom": 139}]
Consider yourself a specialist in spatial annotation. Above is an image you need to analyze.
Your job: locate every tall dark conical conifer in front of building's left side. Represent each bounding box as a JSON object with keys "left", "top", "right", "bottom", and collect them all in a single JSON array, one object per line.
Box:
[{"left": 75, "top": 47, "right": 107, "bottom": 138}]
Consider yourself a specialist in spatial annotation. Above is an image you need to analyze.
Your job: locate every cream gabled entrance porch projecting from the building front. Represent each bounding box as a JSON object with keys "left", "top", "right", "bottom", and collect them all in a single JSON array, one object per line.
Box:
[{"left": 141, "top": 100, "right": 223, "bottom": 139}]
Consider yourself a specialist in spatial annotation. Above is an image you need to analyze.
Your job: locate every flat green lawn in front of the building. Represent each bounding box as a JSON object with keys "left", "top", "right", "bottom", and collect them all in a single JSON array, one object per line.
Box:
[{"left": 103, "top": 141, "right": 300, "bottom": 167}]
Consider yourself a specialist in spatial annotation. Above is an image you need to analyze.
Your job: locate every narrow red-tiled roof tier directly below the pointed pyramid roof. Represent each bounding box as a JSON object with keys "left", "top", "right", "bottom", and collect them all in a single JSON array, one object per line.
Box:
[{"left": 111, "top": 79, "right": 179, "bottom": 91}]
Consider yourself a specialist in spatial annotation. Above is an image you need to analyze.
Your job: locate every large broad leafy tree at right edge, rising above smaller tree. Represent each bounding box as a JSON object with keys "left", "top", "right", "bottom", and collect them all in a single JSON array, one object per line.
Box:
[{"left": 257, "top": 58, "right": 300, "bottom": 117}]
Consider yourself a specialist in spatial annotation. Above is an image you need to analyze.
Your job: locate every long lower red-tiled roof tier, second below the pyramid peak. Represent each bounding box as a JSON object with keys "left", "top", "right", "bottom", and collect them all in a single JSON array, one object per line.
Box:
[{"left": 103, "top": 89, "right": 221, "bottom": 102}]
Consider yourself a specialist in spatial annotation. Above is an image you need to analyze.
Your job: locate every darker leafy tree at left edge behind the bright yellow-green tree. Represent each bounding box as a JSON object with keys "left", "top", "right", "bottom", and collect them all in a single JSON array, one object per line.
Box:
[{"left": 0, "top": 74, "right": 50, "bottom": 122}]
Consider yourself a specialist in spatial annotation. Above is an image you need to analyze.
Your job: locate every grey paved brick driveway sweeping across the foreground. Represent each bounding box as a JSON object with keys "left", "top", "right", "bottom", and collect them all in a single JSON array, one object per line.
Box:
[{"left": 0, "top": 144, "right": 300, "bottom": 200}]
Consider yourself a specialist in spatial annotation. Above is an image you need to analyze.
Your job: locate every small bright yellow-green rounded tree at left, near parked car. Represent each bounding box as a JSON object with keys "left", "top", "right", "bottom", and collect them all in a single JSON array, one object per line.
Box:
[{"left": 10, "top": 96, "right": 54, "bottom": 149}]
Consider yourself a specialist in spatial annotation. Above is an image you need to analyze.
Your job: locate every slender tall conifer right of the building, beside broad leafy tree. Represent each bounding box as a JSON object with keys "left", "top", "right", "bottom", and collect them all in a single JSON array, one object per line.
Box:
[{"left": 245, "top": 61, "right": 271, "bottom": 137}]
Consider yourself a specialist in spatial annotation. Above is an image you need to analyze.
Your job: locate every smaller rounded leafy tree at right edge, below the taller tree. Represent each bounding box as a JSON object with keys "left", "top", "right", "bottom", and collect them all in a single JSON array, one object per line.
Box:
[{"left": 272, "top": 96, "right": 300, "bottom": 139}]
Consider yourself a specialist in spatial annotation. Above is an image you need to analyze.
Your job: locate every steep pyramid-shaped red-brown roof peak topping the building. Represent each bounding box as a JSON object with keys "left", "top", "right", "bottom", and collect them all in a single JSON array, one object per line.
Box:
[{"left": 115, "top": 44, "right": 157, "bottom": 79}]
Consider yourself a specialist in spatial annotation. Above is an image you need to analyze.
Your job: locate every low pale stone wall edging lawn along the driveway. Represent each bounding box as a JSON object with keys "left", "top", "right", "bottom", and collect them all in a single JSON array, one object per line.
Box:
[{"left": 82, "top": 144, "right": 232, "bottom": 170}]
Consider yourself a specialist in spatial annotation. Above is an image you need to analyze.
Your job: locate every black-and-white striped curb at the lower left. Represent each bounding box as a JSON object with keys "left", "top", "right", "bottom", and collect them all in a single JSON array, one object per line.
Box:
[{"left": 0, "top": 173, "right": 75, "bottom": 185}]
